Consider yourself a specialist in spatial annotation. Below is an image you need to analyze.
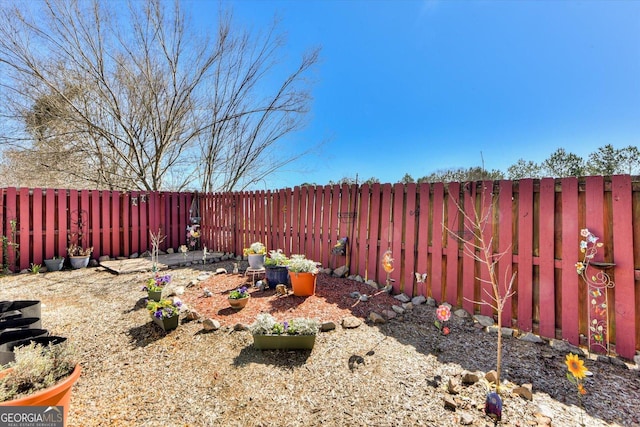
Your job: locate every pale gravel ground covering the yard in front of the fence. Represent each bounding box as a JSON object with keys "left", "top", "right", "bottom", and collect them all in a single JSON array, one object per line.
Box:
[{"left": 0, "top": 265, "right": 640, "bottom": 426}]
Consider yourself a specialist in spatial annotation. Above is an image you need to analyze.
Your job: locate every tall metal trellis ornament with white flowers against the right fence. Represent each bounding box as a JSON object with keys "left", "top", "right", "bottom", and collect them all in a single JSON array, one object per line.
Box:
[{"left": 576, "top": 228, "right": 615, "bottom": 354}]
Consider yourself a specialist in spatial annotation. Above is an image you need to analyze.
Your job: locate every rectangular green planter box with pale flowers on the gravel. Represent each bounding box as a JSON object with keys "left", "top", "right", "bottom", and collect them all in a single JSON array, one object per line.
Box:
[{"left": 249, "top": 313, "right": 320, "bottom": 350}]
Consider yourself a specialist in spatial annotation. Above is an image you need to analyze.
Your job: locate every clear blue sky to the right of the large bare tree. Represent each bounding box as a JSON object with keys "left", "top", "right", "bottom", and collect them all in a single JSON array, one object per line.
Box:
[{"left": 198, "top": 0, "right": 640, "bottom": 188}]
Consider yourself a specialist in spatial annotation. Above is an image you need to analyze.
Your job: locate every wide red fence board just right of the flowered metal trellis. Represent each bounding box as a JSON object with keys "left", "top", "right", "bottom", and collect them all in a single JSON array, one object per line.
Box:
[{"left": 611, "top": 175, "right": 638, "bottom": 359}]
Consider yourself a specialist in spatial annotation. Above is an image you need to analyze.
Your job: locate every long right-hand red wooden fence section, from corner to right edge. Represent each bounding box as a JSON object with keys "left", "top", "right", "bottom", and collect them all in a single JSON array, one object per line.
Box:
[{"left": 200, "top": 176, "right": 640, "bottom": 358}]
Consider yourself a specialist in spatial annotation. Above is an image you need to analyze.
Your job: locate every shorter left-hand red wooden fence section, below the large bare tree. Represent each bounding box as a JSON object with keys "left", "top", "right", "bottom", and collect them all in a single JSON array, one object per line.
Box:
[{"left": 0, "top": 188, "right": 193, "bottom": 270}]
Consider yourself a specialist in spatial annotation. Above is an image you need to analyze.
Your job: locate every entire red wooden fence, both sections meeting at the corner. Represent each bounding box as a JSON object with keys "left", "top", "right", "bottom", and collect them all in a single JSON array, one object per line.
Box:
[{"left": 0, "top": 176, "right": 640, "bottom": 358}]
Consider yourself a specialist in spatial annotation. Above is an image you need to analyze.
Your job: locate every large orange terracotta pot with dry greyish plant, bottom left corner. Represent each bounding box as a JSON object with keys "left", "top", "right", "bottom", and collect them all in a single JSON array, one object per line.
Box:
[{"left": 0, "top": 337, "right": 81, "bottom": 425}]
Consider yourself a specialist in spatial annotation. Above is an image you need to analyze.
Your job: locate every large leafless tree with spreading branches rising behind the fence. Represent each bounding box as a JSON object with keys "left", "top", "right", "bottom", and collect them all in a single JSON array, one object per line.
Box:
[{"left": 0, "top": 0, "right": 318, "bottom": 191}]
